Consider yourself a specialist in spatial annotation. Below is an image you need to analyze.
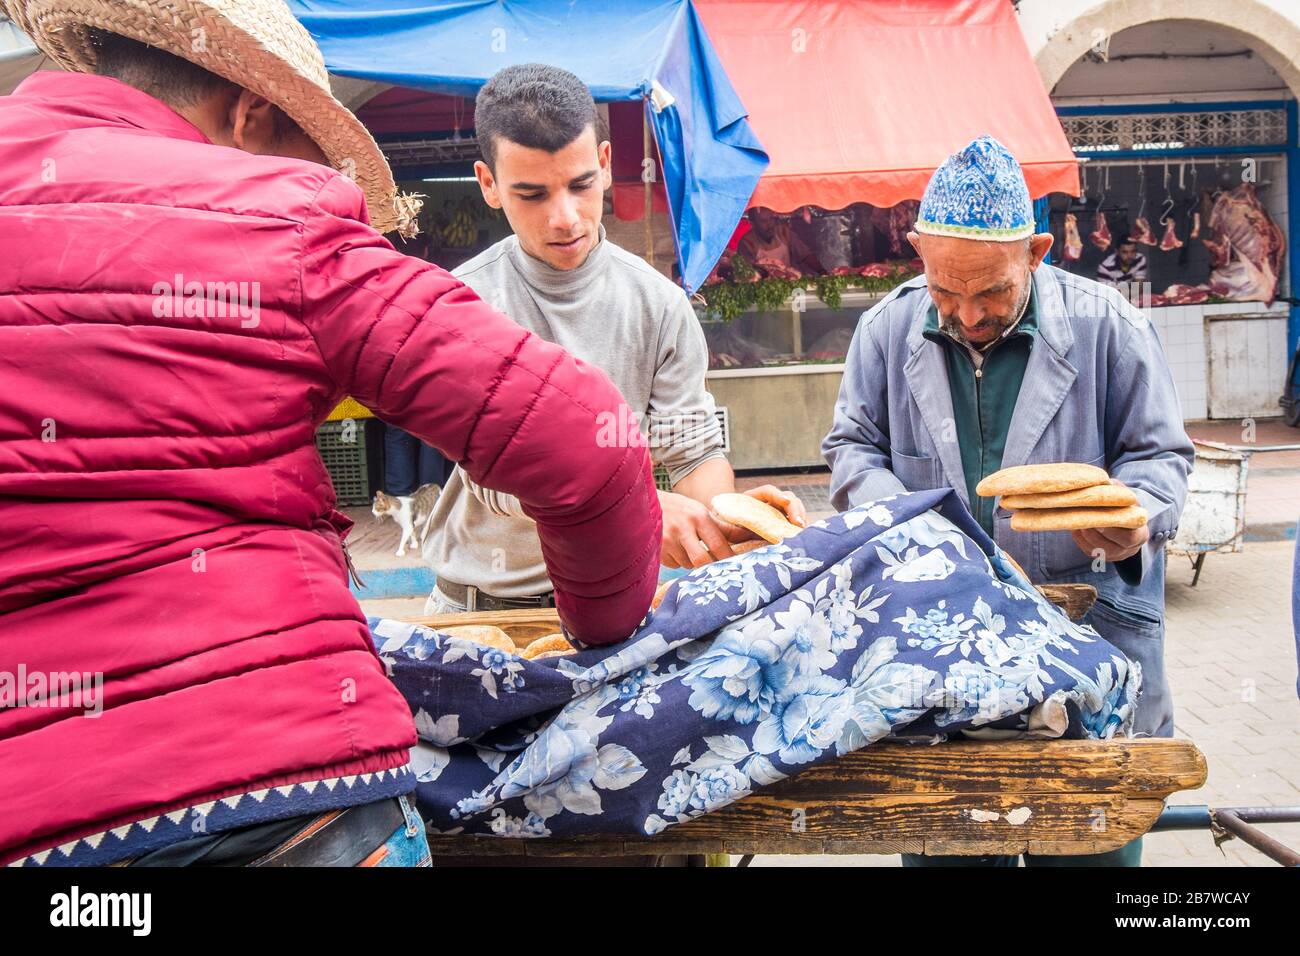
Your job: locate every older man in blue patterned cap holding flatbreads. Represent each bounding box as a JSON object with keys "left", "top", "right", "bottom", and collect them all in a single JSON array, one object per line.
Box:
[{"left": 822, "top": 137, "right": 1192, "bottom": 866}]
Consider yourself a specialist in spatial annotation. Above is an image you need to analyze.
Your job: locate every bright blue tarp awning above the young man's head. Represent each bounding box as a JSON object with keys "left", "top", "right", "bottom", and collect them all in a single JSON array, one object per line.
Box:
[{"left": 289, "top": 0, "right": 767, "bottom": 291}]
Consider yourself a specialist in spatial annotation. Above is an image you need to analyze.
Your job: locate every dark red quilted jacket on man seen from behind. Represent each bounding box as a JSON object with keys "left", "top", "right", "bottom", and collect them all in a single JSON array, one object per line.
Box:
[{"left": 0, "top": 73, "right": 660, "bottom": 864}]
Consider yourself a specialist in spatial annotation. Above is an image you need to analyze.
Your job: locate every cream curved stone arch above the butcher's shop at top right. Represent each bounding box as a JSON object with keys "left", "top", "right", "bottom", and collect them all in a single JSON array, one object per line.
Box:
[{"left": 1034, "top": 0, "right": 1300, "bottom": 99}]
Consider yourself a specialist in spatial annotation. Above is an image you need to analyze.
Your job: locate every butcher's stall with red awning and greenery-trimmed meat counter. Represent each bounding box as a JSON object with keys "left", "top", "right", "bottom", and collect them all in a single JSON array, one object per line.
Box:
[{"left": 681, "top": 3, "right": 1079, "bottom": 470}]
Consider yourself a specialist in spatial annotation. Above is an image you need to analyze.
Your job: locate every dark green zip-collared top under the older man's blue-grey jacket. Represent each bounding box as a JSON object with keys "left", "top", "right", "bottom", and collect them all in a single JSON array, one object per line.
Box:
[{"left": 922, "top": 285, "right": 1039, "bottom": 537}]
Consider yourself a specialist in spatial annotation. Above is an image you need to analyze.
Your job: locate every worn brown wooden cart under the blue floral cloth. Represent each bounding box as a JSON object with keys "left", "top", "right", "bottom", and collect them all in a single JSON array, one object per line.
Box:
[{"left": 405, "top": 585, "right": 1206, "bottom": 864}]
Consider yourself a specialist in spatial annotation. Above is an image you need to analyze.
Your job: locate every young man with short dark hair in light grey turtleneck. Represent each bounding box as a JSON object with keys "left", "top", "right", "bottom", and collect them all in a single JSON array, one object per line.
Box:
[{"left": 423, "top": 64, "right": 806, "bottom": 614}]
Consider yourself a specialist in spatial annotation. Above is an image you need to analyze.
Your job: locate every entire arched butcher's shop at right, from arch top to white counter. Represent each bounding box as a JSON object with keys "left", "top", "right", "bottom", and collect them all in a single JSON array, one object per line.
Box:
[{"left": 1031, "top": 7, "right": 1300, "bottom": 420}]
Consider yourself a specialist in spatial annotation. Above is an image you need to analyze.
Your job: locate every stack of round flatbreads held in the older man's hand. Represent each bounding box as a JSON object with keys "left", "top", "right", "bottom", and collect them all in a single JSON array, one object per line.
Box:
[{"left": 975, "top": 462, "right": 1147, "bottom": 531}]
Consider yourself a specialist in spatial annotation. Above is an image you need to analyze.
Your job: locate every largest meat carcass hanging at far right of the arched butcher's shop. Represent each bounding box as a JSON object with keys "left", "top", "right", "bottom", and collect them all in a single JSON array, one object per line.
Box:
[{"left": 1205, "top": 182, "right": 1286, "bottom": 303}]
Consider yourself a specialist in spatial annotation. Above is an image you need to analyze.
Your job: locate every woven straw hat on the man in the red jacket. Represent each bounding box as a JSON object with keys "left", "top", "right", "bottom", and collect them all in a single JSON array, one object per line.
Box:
[{"left": 0, "top": 0, "right": 420, "bottom": 235}]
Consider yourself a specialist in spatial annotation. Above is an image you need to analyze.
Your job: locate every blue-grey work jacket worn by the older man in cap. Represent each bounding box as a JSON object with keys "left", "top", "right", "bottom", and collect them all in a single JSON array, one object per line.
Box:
[{"left": 822, "top": 264, "right": 1193, "bottom": 736}]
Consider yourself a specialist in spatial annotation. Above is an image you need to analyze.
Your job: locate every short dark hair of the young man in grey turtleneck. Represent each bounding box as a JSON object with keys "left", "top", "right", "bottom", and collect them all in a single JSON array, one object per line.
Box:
[{"left": 475, "top": 62, "right": 608, "bottom": 169}]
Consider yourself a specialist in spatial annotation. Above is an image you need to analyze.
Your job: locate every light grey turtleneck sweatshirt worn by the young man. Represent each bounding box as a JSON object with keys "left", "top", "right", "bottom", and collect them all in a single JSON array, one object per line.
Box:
[{"left": 423, "top": 226, "right": 723, "bottom": 597}]
